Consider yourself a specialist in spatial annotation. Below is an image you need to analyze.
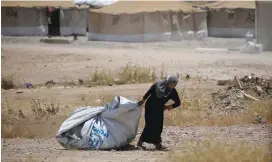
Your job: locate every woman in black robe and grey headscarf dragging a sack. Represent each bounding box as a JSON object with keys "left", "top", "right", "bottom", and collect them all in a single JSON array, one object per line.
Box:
[{"left": 137, "top": 76, "right": 180, "bottom": 149}]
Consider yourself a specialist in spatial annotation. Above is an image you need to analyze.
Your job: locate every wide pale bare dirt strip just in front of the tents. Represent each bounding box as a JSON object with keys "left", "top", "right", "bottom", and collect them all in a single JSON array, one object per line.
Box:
[{"left": 2, "top": 38, "right": 272, "bottom": 84}]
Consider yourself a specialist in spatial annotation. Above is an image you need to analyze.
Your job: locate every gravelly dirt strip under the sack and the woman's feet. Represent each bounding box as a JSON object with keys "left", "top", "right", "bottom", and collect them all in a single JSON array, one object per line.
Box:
[{"left": 1, "top": 125, "right": 272, "bottom": 162}]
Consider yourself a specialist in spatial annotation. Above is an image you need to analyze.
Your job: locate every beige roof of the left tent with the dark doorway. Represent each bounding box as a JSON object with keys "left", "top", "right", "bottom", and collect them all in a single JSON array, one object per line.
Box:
[{"left": 1, "top": 0, "right": 88, "bottom": 8}]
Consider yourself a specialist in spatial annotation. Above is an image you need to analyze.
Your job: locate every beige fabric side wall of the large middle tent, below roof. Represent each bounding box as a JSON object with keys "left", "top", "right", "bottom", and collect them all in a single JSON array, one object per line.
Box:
[{"left": 88, "top": 11, "right": 207, "bottom": 42}]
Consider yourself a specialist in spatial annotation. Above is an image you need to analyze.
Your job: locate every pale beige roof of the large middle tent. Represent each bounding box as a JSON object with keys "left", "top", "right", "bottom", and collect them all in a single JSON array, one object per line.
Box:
[{"left": 91, "top": 1, "right": 204, "bottom": 14}]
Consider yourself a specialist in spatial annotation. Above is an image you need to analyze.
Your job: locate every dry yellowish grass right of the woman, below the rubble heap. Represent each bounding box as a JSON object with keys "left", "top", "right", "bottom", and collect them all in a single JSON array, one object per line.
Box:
[{"left": 165, "top": 98, "right": 272, "bottom": 126}]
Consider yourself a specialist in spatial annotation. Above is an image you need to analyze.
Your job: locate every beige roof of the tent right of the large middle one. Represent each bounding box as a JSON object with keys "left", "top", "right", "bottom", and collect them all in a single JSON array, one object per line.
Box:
[{"left": 198, "top": 1, "right": 255, "bottom": 9}]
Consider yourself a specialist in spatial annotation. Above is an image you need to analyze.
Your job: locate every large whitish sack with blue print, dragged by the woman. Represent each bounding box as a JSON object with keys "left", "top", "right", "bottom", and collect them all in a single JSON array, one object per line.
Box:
[{"left": 56, "top": 96, "right": 141, "bottom": 150}]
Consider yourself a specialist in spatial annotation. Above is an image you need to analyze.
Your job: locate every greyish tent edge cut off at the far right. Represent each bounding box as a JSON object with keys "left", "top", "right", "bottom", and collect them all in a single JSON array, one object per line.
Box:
[{"left": 256, "top": 1, "right": 272, "bottom": 51}]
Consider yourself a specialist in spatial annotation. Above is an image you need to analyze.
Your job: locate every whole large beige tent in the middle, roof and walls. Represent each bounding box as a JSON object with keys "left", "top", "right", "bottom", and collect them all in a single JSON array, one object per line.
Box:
[{"left": 88, "top": 1, "right": 207, "bottom": 42}]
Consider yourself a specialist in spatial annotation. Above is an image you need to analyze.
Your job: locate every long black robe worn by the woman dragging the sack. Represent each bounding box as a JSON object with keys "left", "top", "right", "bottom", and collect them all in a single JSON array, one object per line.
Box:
[{"left": 140, "top": 83, "right": 180, "bottom": 144}]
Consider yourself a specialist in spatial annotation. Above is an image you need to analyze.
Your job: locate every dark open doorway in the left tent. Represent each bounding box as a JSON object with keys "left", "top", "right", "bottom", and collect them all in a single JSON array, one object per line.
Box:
[{"left": 47, "top": 7, "right": 60, "bottom": 36}]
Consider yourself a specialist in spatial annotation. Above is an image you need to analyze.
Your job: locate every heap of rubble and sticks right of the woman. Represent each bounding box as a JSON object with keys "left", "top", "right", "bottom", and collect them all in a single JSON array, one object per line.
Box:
[{"left": 209, "top": 74, "right": 272, "bottom": 113}]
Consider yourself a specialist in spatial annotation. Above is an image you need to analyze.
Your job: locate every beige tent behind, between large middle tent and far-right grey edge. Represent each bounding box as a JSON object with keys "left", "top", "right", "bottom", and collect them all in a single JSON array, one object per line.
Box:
[{"left": 202, "top": 1, "right": 255, "bottom": 38}]
